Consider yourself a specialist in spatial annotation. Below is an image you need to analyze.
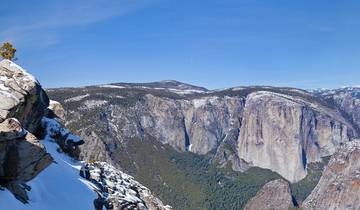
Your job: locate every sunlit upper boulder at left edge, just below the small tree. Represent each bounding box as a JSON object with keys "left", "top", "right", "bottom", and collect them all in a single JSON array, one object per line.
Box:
[{"left": 0, "top": 60, "right": 49, "bottom": 133}]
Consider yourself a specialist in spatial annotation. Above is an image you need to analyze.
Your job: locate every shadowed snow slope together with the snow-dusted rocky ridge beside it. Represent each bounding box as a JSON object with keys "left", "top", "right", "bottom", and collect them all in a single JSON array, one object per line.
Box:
[{"left": 0, "top": 117, "right": 171, "bottom": 210}]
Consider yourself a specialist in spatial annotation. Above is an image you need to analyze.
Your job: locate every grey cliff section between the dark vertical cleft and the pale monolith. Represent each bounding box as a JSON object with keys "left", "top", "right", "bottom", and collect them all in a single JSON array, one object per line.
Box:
[{"left": 185, "top": 96, "right": 245, "bottom": 154}]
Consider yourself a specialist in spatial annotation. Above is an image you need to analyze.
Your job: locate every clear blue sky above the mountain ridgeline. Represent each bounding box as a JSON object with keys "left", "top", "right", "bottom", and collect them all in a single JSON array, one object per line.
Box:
[{"left": 0, "top": 0, "right": 360, "bottom": 89}]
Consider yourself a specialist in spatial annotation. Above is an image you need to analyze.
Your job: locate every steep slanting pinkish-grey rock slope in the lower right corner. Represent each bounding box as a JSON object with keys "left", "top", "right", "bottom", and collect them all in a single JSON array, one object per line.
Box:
[{"left": 303, "top": 140, "right": 360, "bottom": 210}]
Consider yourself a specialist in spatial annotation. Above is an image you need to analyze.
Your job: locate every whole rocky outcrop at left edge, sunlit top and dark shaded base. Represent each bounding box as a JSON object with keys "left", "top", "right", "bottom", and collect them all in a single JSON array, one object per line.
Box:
[{"left": 0, "top": 60, "right": 52, "bottom": 202}]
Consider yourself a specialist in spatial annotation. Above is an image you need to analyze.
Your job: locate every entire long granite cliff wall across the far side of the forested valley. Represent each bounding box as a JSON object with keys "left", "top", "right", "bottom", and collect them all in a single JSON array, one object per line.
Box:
[{"left": 49, "top": 83, "right": 358, "bottom": 182}]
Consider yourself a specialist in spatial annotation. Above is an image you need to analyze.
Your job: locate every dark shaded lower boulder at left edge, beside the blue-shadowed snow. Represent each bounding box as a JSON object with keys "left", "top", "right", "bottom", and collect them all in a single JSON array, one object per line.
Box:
[{"left": 0, "top": 118, "right": 52, "bottom": 202}]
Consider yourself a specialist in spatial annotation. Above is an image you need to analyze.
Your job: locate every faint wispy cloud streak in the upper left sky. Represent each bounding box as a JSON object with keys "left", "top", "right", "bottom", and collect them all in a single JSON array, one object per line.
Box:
[{"left": 0, "top": 0, "right": 155, "bottom": 45}]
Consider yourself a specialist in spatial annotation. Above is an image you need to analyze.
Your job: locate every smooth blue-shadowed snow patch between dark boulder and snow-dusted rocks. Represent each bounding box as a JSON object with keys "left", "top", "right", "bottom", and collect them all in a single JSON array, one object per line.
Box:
[{"left": 0, "top": 131, "right": 97, "bottom": 210}]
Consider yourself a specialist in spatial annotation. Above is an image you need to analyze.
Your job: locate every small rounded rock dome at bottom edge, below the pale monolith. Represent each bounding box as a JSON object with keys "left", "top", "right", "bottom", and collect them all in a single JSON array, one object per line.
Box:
[{"left": 244, "top": 179, "right": 294, "bottom": 210}]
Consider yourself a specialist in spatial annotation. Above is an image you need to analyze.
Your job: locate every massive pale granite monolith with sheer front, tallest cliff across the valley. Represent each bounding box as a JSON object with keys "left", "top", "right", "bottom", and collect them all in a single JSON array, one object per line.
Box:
[{"left": 238, "top": 91, "right": 353, "bottom": 182}]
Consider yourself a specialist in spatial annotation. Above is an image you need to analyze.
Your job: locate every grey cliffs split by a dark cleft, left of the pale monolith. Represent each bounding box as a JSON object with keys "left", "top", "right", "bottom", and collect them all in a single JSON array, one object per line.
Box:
[{"left": 140, "top": 95, "right": 243, "bottom": 154}]
